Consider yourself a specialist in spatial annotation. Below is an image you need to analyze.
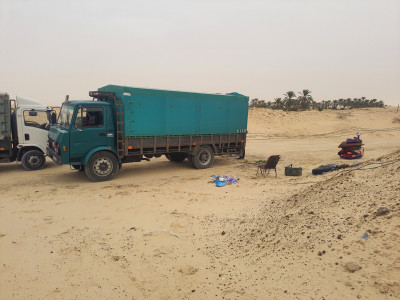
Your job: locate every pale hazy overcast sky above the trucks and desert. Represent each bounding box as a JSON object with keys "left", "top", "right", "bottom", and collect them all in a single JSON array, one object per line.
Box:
[{"left": 0, "top": 0, "right": 400, "bottom": 106}]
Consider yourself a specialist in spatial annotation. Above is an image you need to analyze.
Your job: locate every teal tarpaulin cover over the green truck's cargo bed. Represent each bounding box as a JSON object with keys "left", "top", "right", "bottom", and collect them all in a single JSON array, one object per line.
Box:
[{"left": 99, "top": 85, "right": 248, "bottom": 137}]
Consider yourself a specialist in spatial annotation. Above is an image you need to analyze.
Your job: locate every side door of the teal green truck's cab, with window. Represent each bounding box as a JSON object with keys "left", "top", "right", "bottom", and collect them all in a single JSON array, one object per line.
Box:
[{"left": 69, "top": 106, "right": 107, "bottom": 163}]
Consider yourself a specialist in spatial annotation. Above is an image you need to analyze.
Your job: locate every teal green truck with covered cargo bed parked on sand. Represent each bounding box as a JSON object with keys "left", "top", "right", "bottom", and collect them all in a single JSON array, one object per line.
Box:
[{"left": 47, "top": 85, "right": 249, "bottom": 181}]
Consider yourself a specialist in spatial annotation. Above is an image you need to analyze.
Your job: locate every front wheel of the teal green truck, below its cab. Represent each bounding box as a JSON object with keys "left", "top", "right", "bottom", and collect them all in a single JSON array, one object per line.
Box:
[{"left": 85, "top": 151, "right": 119, "bottom": 181}]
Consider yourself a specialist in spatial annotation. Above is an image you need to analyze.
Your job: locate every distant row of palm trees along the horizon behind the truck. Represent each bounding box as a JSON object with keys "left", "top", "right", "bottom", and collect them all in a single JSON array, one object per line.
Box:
[{"left": 250, "top": 90, "right": 385, "bottom": 111}]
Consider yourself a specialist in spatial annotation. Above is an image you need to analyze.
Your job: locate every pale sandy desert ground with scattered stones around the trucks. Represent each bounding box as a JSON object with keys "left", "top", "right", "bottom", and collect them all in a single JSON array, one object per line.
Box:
[{"left": 0, "top": 108, "right": 400, "bottom": 299}]
